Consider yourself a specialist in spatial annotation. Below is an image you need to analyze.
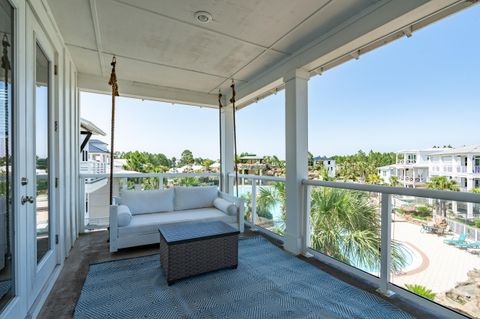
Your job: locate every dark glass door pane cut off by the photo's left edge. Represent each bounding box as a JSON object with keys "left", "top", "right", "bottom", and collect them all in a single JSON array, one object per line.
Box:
[{"left": 0, "top": 0, "right": 14, "bottom": 312}]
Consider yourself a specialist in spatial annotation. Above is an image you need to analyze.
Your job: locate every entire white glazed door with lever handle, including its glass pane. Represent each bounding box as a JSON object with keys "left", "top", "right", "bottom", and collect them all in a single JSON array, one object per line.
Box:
[{"left": 25, "top": 10, "right": 58, "bottom": 304}]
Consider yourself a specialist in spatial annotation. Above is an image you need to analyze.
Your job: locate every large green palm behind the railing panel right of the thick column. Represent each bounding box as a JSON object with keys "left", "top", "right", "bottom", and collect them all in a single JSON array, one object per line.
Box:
[{"left": 310, "top": 188, "right": 405, "bottom": 271}]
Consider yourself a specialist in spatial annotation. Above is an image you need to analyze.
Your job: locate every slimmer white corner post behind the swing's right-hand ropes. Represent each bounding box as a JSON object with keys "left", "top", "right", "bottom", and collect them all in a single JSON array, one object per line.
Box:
[{"left": 220, "top": 104, "right": 235, "bottom": 194}]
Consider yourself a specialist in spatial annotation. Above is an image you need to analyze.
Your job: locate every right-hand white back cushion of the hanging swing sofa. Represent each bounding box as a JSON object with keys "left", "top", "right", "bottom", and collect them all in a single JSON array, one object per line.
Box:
[{"left": 175, "top": 186, "right": 218, "bottom": 210}]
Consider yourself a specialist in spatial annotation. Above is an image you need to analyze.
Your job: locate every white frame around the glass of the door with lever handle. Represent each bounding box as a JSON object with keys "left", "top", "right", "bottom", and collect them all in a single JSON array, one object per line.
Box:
[{"left": 25, "top": 3, "right": 59, "bottom": 307}]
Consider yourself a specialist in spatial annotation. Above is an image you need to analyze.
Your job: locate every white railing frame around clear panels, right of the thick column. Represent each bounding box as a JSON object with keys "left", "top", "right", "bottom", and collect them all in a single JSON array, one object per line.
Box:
[{"left": 302, "top": 180, "right": 480, "bottom": 318}]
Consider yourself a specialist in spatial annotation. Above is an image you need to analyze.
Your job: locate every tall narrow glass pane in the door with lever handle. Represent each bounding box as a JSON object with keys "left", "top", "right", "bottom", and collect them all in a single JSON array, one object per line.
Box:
[{"left": 35, "top": 44, "right": 51, "bottom": 263}]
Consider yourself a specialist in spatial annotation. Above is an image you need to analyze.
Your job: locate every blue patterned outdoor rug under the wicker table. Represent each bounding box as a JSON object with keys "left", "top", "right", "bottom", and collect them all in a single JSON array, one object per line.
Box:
[{"left": 74, "top": 237, "right": 413, "bottom": 319}]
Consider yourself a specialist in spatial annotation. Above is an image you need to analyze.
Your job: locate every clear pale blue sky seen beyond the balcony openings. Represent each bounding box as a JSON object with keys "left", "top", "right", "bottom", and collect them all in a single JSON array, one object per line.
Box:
[{"left": 81, "top": 5, "right": 480, "bottom": 159}]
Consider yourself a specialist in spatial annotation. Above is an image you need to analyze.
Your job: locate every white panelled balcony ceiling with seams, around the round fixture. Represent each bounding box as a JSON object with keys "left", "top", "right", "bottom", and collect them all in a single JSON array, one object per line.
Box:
[{"left": 48, "top": 0, "right": 378, "bottom": 98}]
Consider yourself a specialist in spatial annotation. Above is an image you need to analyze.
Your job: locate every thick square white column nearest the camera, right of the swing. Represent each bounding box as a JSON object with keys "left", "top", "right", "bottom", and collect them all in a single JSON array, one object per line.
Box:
[{"left": 284, "top": 70, "right": 309, "bottom": 254}]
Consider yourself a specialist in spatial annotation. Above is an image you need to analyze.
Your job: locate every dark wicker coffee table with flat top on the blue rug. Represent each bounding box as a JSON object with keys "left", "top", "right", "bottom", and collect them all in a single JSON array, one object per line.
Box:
[{"left": 158, "top": 222, "right": 239, "bottom": 286}]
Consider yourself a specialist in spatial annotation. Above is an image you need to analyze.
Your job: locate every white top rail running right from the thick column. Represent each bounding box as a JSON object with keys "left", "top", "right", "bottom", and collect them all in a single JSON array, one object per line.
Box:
[{"left": 302, "top": 179, "right": 480, "bottom": 204}]
